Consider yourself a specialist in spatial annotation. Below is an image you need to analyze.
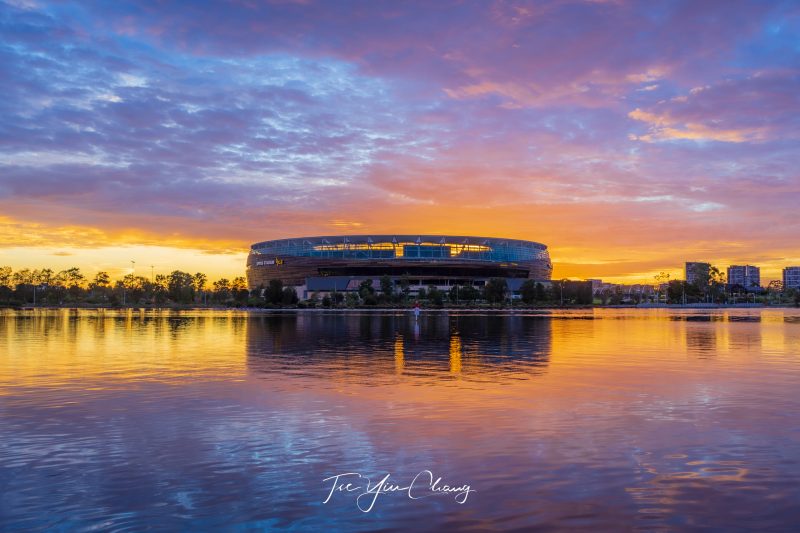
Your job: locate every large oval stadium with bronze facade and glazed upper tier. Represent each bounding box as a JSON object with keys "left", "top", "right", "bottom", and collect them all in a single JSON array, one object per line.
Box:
[{"left": 247, "top": 235, "right": 553, "bottom": 296}]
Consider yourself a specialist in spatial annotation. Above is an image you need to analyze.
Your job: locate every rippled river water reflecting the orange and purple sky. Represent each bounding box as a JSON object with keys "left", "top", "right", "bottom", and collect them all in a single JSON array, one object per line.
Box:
[{"left": 0, "top": 309, "right": 800, "bottom": 531}]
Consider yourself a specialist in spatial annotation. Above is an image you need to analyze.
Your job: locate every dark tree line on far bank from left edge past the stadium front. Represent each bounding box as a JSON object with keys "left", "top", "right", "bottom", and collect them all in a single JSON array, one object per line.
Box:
[{"left": 0, "top": 266, "right": 592, "bottom": 307}]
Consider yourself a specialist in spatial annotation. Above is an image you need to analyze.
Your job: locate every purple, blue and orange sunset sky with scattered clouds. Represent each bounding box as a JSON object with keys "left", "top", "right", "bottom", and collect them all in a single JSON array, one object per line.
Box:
[{"left": 0, "top": 0, "right": 800, "bottom": 283}]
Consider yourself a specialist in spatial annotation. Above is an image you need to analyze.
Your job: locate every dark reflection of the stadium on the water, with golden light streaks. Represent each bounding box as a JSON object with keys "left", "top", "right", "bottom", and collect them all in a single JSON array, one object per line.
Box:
[{"left": 247, "top": 313, "right": 552, "bottom": 384}]
